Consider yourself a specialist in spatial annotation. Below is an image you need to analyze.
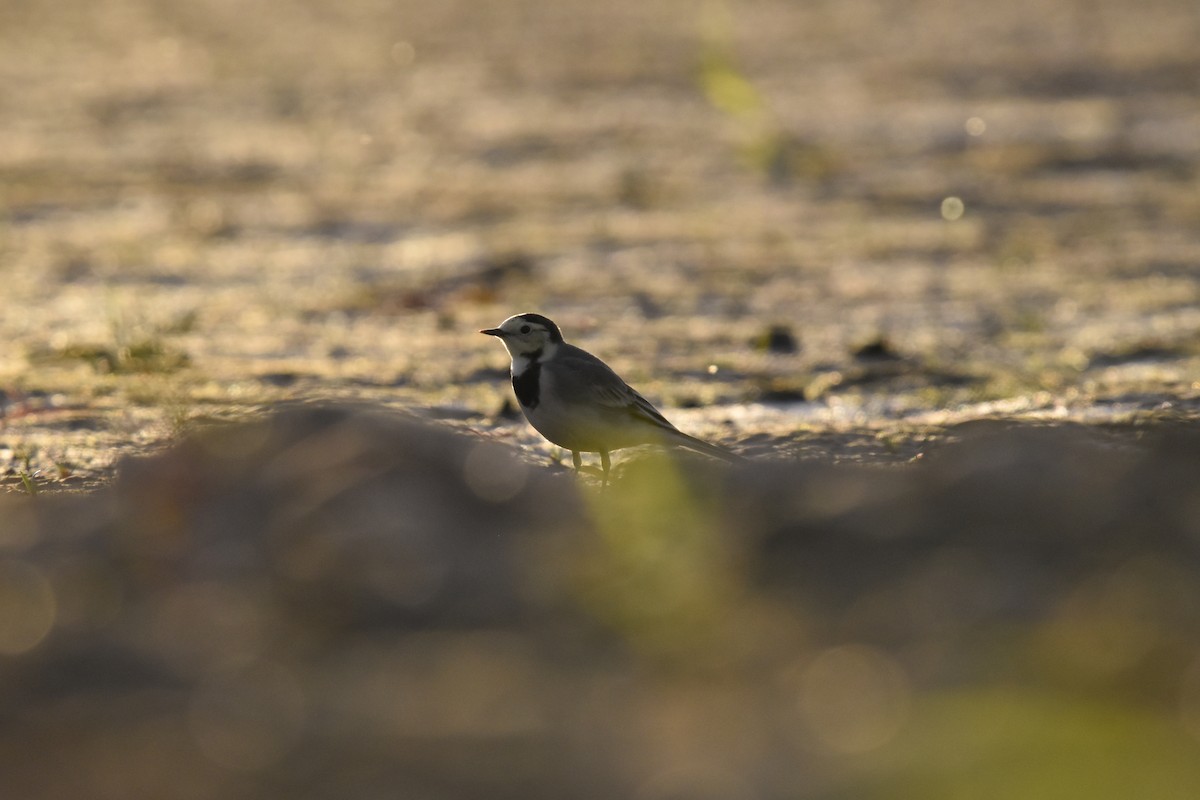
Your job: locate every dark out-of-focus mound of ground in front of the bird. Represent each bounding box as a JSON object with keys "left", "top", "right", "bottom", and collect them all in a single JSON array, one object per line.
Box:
[{"left": 0, "top": 409, "right": 1200, "bottom": 800}]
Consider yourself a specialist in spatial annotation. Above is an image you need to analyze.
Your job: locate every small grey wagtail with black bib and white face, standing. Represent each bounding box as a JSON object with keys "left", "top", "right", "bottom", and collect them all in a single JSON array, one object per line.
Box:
[{"left": 480, "top": 314, "right": 744, "bottom": 483}]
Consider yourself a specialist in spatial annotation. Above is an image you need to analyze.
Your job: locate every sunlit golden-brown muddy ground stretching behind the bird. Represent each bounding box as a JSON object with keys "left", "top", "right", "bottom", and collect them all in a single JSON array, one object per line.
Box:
[{"left": 0, "top": 0, "right": 1200, "bottom": 491}]
